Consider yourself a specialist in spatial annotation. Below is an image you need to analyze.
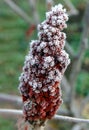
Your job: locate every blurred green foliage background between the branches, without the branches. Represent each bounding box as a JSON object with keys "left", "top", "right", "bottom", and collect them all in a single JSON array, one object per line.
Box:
[{"left": 0, "top": 0, "right": 89, "bottom": 130}]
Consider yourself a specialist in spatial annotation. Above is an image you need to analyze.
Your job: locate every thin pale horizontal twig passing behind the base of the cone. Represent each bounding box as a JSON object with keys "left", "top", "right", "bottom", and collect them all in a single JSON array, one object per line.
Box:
[{"left": 0, "top": 109, "right": 89, "bottom": 123}]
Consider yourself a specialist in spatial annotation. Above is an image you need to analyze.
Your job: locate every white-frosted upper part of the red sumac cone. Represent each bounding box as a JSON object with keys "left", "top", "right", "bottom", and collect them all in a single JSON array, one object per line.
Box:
[{"left": 19, "top": 4, "right": 70, "bottom": 95}]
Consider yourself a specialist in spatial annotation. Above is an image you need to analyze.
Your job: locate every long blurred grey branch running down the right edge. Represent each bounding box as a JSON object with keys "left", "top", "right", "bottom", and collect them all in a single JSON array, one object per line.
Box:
[{"left": 70, "top": 3, "right": 89, "bottom": 116}]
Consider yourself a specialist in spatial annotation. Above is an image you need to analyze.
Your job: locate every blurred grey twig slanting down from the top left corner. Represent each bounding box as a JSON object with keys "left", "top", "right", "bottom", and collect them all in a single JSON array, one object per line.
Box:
[{"left": 4, "top": 0, "right": 33, "bottom": 24}]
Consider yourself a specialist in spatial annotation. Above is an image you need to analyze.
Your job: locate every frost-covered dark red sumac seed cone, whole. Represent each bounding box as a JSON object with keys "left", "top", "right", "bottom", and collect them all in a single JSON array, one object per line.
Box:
[{"left": 19, "top": 4, "right": 70, "bottom": 125}]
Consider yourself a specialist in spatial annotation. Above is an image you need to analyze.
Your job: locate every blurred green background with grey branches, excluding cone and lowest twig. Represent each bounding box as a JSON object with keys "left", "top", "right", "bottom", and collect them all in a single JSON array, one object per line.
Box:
[{"left": 0, "top": 0, "right": 89, "bottom": 130}]
